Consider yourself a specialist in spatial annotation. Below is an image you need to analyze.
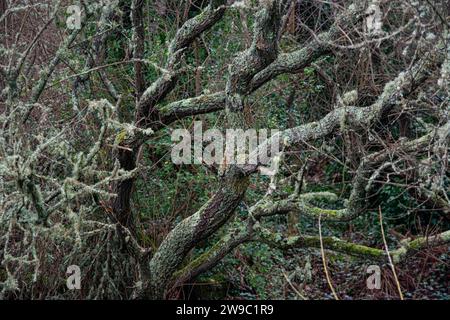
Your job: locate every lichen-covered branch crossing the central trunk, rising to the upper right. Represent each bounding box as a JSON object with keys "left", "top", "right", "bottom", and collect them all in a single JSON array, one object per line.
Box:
[{"left": 130, "top": 1, "right": 370, "bottom": 129}]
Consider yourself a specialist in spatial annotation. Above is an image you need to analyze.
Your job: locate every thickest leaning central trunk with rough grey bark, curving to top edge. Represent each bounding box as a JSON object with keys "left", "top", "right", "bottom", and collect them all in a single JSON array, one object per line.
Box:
[{"left": 149, "top": 1, "right": 280, "bottom": 298}]
